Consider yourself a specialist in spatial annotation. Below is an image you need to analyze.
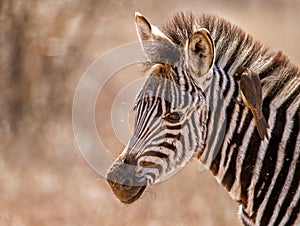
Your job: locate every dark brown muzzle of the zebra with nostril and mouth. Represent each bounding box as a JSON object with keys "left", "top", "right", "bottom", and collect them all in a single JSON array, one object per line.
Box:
[{"left": 106, "top": 163, "right": 147, "bottom": 204}]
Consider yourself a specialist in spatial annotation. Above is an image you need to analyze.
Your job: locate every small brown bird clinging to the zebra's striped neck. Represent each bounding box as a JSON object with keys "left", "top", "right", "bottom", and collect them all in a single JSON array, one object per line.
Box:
[{"left": 234, "top": 67, "right": 269, "bottom": 140}]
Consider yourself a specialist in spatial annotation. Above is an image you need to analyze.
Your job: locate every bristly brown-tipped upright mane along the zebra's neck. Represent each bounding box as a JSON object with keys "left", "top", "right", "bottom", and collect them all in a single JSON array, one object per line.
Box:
[{"left": 160, "top": 12, "right": 300, "bottom": 83}]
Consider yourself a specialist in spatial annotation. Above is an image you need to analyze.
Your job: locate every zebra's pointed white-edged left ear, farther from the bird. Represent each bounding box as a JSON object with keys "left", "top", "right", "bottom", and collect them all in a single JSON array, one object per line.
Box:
[{"left": 135, "top": 12, "right": 172, "bottom": 49}]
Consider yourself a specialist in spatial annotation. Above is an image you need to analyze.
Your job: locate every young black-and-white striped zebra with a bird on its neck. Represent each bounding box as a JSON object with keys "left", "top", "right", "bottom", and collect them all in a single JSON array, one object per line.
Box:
[{"left": 107, "top": 12, "right": 300, "bottom": 225}]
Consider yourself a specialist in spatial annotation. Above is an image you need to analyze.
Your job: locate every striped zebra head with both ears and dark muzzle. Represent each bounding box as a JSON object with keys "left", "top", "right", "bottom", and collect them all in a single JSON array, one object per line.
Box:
[{"left": 107, "top": 13, "right": 214, "bottom": 203}]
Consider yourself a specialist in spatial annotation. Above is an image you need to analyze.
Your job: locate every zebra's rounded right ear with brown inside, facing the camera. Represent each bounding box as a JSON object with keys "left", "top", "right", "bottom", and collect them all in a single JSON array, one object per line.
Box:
[{"left": 185, "top": 28, "right": 215, "bottom": 77}]
